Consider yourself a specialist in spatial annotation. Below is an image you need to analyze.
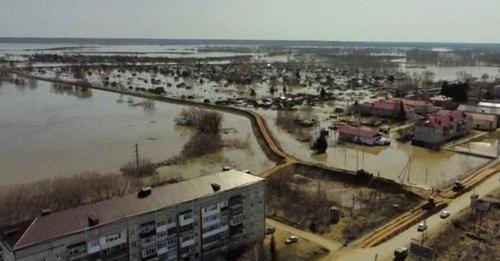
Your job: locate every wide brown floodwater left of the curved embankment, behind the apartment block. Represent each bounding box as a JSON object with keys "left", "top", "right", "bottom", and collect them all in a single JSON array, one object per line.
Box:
[{"left": 0, "top": 81, "right": 272, "bottom": 185}]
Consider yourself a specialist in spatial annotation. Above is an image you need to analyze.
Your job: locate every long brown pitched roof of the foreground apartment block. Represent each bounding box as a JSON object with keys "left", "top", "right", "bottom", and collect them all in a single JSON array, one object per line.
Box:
[{"left": 0, "top": 170, "right": 263, "bottom": 250}]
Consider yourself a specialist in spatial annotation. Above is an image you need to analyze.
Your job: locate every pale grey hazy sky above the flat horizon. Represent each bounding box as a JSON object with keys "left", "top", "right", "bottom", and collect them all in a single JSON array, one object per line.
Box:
[{"left": 0, "top": 0, "right": 500, "bottom": 43}]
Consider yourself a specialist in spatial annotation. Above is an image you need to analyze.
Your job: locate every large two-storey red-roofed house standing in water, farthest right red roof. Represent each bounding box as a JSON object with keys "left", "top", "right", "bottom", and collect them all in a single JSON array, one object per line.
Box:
[{"left": 412, "top": 111, "right": 472, "bottom": 148}]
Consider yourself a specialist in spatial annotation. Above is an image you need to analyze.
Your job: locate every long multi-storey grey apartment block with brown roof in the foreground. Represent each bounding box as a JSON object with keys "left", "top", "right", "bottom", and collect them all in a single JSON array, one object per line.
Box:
[{"left": 0, "top": 170, "right": 265, "bottom": 261}]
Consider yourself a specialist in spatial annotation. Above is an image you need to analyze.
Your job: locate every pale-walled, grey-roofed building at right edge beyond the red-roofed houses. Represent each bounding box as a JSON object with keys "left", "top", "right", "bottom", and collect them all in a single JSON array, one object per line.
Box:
[{"left": 457, "top": 104, "right": 500, "bottom": 131}]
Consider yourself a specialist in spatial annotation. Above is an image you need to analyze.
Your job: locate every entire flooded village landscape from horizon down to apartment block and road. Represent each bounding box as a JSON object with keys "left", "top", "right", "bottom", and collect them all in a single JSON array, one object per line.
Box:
[{"left": 0, "top": 41, "right": 500, "bottom": 260}]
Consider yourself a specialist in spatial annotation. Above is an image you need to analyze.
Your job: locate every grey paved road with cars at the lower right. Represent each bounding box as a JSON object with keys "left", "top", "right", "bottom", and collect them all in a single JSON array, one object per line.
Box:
[{"left": 329, "top": 173, "right": 500, "bottom": 261}]
